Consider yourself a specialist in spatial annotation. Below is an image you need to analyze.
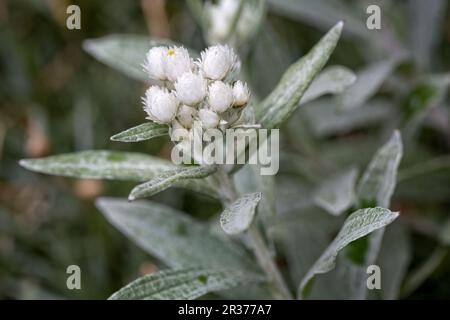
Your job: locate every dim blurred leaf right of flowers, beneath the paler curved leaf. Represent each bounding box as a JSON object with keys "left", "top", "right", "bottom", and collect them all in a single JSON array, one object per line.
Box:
[{"left": 299, "top": 98, "right": 392, "bottom": 138}]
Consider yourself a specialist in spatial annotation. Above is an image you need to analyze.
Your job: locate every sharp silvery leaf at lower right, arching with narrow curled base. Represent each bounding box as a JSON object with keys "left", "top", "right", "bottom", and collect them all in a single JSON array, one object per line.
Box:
[{"left": 298, "top": 207, "right": 398, "bottom": 298}]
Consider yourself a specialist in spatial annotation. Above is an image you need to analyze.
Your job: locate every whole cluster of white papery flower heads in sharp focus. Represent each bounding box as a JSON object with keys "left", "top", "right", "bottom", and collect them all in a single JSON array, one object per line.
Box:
[{"left": 142, "top": 45, "right": 250, "bottom": 136}]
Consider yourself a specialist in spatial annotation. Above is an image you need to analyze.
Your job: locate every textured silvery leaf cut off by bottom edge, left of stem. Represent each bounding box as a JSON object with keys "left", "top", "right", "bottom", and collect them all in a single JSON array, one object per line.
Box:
[{"left": 109, "top": 267, "right": 262, "bottom": 300}]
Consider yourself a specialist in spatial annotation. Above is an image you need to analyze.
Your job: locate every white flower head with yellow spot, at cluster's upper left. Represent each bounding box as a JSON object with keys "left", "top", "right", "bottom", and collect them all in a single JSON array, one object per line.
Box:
[{"left": 163, "top": 47, "right": 193, "bottom": 82}]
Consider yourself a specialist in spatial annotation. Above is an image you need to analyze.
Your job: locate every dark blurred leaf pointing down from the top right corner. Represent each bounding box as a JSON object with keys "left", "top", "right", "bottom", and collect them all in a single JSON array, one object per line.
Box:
[{"left": 408, "top": 0, "right": 447, "bottom": 68}]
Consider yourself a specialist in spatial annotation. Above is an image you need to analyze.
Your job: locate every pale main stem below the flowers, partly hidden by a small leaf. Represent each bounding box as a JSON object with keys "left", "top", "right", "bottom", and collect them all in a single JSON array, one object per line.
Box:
[{"left": 219, "top": 169, "right": 294, "bottom": 300}]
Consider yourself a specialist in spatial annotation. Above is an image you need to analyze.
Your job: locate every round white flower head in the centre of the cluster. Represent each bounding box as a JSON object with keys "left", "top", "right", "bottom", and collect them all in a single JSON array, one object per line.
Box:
[{"left": 174, "top": 72, "right": 207, "bottom": 105}]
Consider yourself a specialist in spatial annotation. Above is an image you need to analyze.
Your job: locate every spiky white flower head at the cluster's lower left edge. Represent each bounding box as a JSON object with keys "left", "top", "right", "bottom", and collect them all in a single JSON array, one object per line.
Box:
[{"left": 143, "top": 86, "right": 178, "bottom": 123}]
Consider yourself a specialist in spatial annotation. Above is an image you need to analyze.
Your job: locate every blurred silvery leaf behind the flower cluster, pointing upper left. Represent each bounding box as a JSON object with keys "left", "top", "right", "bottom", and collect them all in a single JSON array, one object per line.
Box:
[{"left": 83, "top": 34, "right": 182, "bottom": 82}]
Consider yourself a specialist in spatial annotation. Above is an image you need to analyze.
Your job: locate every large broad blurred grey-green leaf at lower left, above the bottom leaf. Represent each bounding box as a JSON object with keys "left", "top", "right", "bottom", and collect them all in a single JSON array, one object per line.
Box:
[{"left": 97, "top": 198, "right": 258, "bottom": 272}]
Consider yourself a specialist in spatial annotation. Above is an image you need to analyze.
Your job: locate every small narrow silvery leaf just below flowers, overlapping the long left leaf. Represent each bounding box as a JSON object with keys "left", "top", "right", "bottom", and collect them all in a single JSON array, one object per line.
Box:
[{"left": 128, "top": 166, "right": 217, "bottom": 201}]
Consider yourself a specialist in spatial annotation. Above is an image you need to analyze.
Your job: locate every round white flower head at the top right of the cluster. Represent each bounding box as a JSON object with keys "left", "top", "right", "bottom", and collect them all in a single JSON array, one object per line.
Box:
[{"left": 200, "top": 45, "right": 239, "bottom": 80}]
